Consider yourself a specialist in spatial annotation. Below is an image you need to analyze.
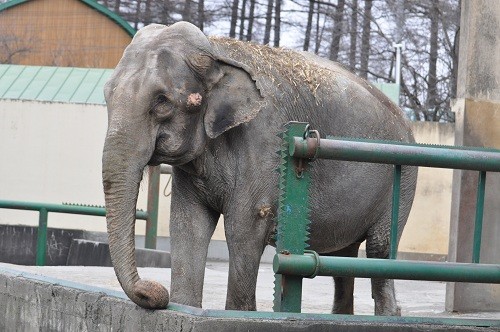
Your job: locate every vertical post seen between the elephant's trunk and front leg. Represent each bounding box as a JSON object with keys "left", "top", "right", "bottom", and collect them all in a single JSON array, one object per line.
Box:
[{"left": 145, "top": 166, "right": 161, "bottom": 249}]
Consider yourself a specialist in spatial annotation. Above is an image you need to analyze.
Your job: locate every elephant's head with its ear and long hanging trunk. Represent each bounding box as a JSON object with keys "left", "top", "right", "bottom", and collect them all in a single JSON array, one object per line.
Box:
[{"left": 103, "top": 22, "right": 262, "bottom": 308}]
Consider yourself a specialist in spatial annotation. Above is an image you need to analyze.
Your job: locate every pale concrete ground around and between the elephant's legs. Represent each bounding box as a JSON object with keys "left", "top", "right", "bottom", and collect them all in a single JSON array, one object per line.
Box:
[{"left": 0, "top": 262, "right": 500, "bottom": 319}]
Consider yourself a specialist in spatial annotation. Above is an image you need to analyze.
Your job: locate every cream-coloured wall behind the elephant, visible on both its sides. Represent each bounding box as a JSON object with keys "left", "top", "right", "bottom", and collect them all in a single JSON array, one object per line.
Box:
[{"left": 0, "top": 100, "right": 453, "bottom": 255}]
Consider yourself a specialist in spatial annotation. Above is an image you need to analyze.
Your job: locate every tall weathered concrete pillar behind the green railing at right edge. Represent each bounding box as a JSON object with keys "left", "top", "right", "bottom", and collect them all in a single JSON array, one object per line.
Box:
[{"left": 446, "top": 0, "right": 500, "bottom": 311}]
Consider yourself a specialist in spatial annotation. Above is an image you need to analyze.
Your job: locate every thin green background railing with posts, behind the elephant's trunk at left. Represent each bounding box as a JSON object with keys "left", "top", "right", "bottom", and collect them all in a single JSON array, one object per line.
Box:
[{"left": 0, "top": 165, "right": 172, "bottom": 266}]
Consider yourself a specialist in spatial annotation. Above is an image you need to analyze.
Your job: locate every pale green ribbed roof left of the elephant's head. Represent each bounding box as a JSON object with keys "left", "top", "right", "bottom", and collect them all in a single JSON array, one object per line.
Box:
[{"left": 0, "top": 65, "right": 113, "bottom": 105}]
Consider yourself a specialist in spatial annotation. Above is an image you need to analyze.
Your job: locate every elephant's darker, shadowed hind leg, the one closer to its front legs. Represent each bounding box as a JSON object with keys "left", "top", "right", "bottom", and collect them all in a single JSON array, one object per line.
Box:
[{"left": 326, "top": 243, "right": 360, "bottom": 315}]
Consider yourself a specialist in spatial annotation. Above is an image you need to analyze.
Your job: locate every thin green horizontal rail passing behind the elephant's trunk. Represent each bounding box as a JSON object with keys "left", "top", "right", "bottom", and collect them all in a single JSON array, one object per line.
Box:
[{"left": 0, "top": 200, "right": 148, "bottom": 220}]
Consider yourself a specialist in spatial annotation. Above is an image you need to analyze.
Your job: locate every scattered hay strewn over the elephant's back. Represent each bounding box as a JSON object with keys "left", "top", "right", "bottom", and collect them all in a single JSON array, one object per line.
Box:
[{"left": 210, "top": 37, "right": 333, "bottom": 94}]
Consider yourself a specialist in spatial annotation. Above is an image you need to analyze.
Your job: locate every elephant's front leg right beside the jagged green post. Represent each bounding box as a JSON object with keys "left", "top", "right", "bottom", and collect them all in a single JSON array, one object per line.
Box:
[{"left": 225, "top": 210, "right": 267, "bottom": 310}]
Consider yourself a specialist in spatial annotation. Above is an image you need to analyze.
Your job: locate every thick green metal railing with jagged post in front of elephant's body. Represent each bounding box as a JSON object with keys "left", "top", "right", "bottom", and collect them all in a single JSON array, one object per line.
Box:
[{"left": 273, "top": 122, "right": 500, "bottom": 326}]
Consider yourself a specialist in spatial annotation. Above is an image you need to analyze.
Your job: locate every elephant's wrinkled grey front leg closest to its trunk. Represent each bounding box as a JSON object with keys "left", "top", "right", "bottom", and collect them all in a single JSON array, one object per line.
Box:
[{"left": 170, "top": 184, "right": 219, "bottom": 308}]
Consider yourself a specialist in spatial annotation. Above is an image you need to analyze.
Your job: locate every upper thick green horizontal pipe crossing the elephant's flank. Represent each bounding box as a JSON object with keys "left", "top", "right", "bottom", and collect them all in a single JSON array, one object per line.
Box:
[{"left": 290, "top": 137, "right": 500, "bottom": 172}]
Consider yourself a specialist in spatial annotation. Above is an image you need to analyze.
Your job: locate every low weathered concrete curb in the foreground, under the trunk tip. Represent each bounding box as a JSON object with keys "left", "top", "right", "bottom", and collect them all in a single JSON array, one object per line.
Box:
[{"left": 0, "top": 268, "right": 500, "bottom": 332}]
